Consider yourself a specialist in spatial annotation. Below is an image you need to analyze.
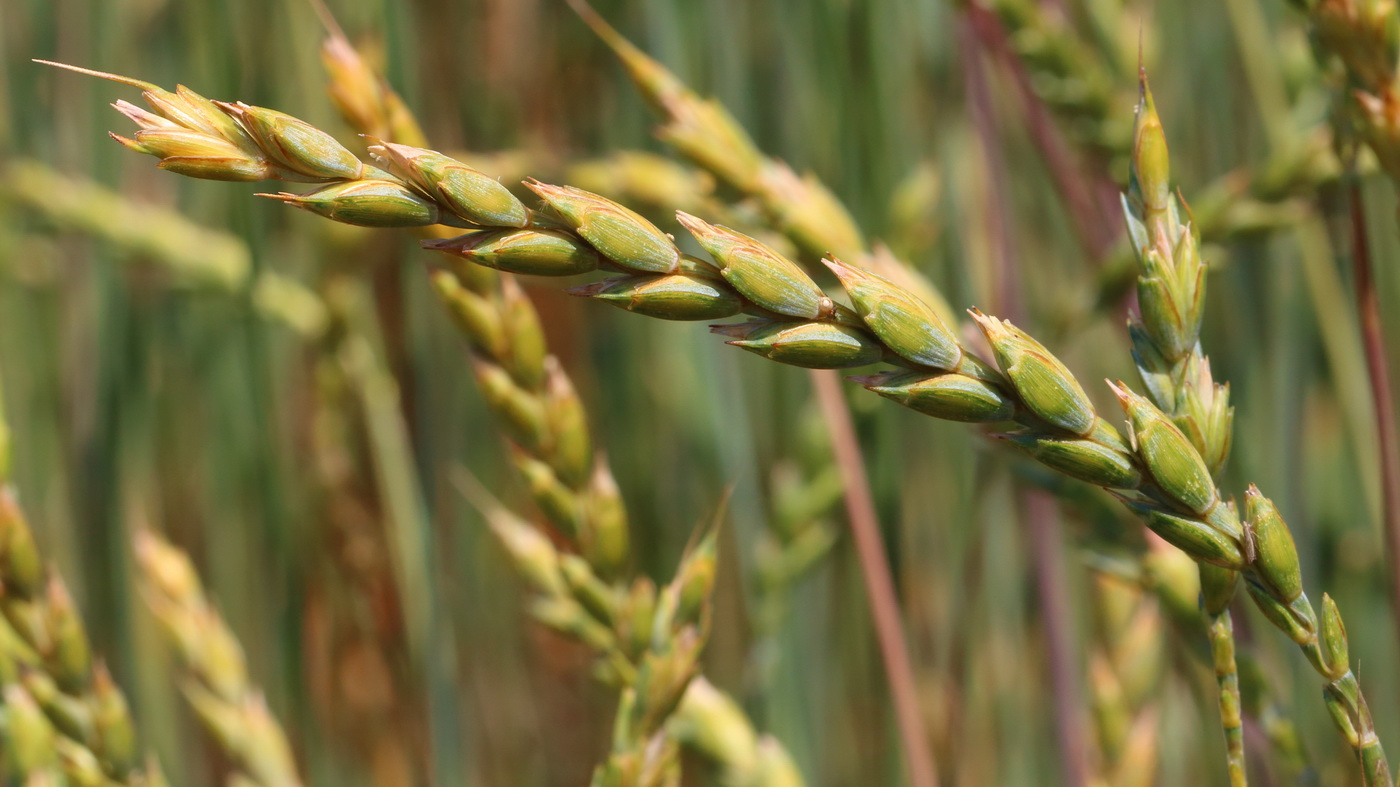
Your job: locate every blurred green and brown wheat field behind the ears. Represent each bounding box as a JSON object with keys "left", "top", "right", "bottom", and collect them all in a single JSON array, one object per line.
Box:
[{"left": 0, "top": 0, "right": 1400, "bottom": 786}]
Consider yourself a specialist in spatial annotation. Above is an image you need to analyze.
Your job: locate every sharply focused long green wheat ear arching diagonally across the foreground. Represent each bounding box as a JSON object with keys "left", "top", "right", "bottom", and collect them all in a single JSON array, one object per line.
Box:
[{"left": 46, "top": 55, "right": 1389, "bottom": 784}]
